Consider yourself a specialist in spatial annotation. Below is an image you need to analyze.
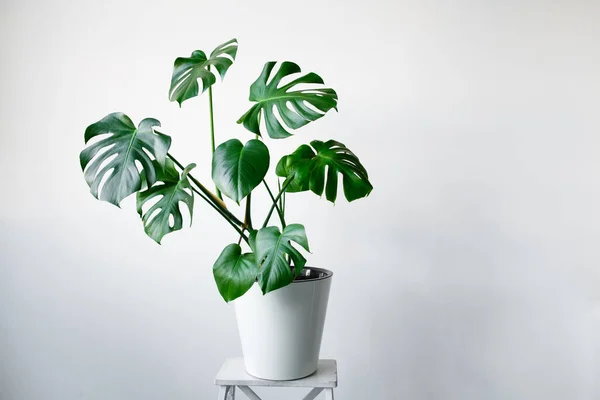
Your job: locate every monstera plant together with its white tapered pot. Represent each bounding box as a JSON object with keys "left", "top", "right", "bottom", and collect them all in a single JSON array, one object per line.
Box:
[{"left": 80, "top": 39, "right": 373, "bottom": 380}]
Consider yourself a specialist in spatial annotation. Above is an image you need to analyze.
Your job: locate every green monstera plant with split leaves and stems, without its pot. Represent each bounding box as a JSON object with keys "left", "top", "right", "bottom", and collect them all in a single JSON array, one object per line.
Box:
[{"left": 79, "top": 39, "right": 373, "bottom": 301}]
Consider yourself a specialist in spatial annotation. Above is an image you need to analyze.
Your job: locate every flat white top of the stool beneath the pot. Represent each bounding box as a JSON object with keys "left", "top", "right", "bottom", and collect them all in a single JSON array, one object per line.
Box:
[{"left": 215, "top": 357, "right": 337, "bottom": 388}]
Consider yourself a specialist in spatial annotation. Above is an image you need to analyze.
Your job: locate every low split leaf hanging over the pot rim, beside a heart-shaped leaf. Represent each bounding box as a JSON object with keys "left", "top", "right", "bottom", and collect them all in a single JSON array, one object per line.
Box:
[{"left": 254, "top": 224, "right": 310, "bottom": 294}]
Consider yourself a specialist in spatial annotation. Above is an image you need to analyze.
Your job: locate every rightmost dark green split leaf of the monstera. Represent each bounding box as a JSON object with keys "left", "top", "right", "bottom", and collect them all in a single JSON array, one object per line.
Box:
[{"left": 275, "top": 140, "right": 373, "bottom": 203}]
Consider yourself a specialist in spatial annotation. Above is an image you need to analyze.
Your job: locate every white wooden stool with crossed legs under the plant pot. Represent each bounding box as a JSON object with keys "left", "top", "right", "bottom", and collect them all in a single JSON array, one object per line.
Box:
[{"left": 215, "top": 357, "right": 337, "bottom": 400}]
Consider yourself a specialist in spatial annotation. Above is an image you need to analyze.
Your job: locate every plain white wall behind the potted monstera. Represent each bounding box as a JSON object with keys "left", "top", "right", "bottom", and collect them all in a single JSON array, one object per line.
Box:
[{"left": 0, "top": 0, "right": 600, "bottom": 400}]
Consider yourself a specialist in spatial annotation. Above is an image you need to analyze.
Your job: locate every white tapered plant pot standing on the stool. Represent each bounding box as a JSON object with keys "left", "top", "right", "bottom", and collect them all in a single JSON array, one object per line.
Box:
[{"left": 234, "top": 267, "right": 333, "bottom": 380}]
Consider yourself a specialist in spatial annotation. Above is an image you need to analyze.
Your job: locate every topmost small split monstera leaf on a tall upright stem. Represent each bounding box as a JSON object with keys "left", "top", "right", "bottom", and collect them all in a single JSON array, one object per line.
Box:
[{"left": 169, "top": 39, "right": 238, "bottom": 107}]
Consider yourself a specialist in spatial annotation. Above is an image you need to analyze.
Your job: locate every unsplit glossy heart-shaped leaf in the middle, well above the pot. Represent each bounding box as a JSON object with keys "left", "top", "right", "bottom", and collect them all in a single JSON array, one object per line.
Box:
[{"left": 212, "top": 139, "right": 270, "bottom": 203}]
